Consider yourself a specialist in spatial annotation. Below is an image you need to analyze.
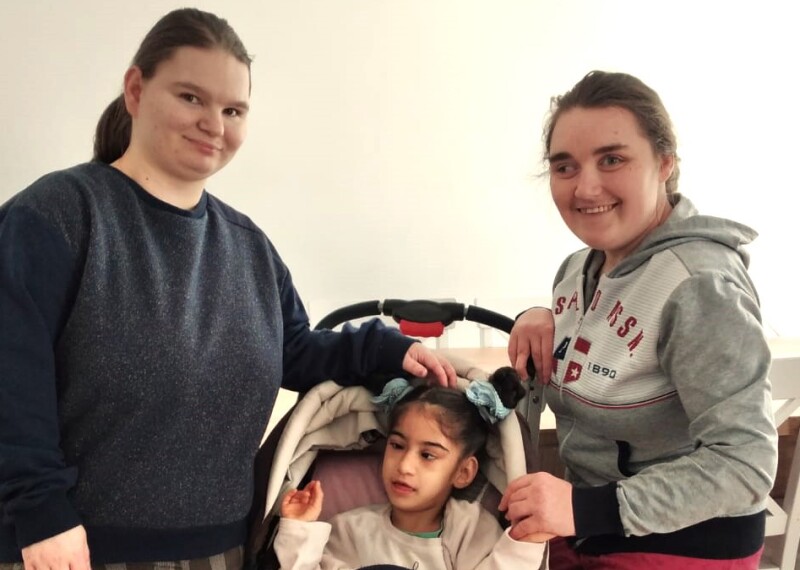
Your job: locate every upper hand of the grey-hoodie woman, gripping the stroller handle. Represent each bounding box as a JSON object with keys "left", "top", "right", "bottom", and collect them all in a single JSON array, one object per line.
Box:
[{"left": 508, "top": 307, "right": 555, "bottom": 384}]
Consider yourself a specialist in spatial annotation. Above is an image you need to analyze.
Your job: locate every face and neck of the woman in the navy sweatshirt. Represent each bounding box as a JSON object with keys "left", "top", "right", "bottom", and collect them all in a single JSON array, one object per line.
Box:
[{"left": 117, "top": 47, "right": 250, "bottom": 201}]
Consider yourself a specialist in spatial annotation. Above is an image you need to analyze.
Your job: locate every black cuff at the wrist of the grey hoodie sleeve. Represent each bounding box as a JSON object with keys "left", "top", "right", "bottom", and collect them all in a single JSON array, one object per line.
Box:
[{"left": 572, "top": 483, "right": 624, "bottom": 538}]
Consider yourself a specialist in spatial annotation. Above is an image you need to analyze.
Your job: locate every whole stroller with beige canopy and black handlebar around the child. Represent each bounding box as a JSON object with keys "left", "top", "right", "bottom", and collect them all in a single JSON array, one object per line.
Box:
[{"left": 245, "top": 299, "right": 542, "bottom": 570}]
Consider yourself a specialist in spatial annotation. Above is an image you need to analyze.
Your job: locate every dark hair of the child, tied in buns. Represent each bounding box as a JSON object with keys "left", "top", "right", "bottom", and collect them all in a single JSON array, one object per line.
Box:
[{"left": 389, "top": 366, "right": 525, "bottom": 457}]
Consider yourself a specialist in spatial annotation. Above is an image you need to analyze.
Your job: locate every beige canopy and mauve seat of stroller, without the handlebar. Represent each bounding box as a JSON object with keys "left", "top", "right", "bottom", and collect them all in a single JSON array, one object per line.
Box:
[{"left": 248, "top": 363, "right": 536, "bottom": 570}]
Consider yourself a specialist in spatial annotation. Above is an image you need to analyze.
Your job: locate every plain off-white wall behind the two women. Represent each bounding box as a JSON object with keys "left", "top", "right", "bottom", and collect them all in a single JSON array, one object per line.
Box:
[{"left": 0, "top": 0, "right": 800, "bottom": 335}]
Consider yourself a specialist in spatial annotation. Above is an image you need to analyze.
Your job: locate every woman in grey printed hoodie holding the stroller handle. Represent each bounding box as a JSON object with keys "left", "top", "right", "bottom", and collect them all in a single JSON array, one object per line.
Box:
[{"left": 501, "top": 71, "right": 777, "bottom": 570}]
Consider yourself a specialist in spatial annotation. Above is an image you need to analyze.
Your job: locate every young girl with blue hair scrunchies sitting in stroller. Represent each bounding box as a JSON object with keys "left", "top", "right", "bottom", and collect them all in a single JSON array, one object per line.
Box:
[{"left": 274, "top": 367, "right": 549, "bottom": 570}]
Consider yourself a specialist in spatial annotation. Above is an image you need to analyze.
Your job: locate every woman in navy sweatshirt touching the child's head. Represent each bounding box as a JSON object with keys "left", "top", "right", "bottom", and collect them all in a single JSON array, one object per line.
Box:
[{"left": 0, "top": 9, "right": 455, "bottom": 570}]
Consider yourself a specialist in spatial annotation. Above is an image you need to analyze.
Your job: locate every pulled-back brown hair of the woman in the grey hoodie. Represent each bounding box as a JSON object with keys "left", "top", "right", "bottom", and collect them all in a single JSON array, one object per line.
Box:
[{"left": 542, "top": 71, "right": 680, "bottom": 194}]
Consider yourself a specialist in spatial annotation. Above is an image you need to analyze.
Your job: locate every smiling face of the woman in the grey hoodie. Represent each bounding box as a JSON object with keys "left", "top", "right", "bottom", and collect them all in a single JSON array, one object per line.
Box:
[{"left": 548, "top": 107, "right": 674, "bottom": 272}]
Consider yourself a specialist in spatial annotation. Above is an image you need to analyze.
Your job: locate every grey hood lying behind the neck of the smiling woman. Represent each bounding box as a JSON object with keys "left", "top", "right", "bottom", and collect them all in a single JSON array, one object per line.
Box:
[{"left": 609, "top": 193, "right": 758, "bottom": 277}]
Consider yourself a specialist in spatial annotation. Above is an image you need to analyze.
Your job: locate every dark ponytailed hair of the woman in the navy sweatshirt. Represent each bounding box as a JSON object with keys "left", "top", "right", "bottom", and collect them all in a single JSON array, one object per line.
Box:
[{"left": 92, "top": 8, "right": 252, "bottom": 164}]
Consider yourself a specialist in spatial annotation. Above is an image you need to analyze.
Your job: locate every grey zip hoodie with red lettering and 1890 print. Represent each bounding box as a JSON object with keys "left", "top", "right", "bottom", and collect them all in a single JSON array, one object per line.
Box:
[{"left": 546, "top": 194, "right": 777, "bottom": 558}]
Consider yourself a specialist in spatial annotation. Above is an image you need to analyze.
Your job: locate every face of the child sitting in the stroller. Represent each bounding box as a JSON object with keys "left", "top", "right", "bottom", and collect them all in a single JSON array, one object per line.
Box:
[{"left": 382, "top": 404, "right": 478, "bottom": 532}]
